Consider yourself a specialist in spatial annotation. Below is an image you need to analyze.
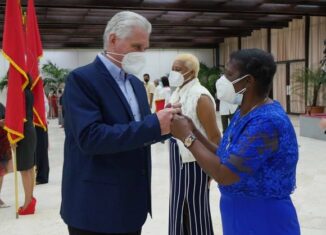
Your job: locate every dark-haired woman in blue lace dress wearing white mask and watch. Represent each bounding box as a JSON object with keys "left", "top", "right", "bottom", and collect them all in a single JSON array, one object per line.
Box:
[{"left": 171, "top": 49, "right": 300, "bottom": 235}]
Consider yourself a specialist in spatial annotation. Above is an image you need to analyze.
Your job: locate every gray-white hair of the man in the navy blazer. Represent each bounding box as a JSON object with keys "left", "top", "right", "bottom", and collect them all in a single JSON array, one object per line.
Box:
[{"left": 103, "top": 11, "right": 152, "bottom": 50}]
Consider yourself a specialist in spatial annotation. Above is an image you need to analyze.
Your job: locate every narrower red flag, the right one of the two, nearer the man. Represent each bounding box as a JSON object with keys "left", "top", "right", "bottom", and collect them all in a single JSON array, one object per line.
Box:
[{"left": 26, "top": 0, "right": 46, "bottom": 130}]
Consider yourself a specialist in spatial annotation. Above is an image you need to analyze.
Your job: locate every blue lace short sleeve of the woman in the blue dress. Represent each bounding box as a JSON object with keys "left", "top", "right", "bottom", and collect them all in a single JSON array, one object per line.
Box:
[{"left": 222, "top": 119, "right": 279, "bottom": 178}]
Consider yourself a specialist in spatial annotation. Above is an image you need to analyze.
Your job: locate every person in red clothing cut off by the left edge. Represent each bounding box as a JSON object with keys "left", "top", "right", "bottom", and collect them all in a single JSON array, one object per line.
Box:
[{"left": 0, "top": 103, "right": 12, "bottom": 208}]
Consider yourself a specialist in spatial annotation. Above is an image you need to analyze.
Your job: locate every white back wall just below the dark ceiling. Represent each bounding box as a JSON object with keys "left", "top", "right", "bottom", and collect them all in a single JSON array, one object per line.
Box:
[{"left": 0, "top": 49, "right": 214, "bottom": 103}]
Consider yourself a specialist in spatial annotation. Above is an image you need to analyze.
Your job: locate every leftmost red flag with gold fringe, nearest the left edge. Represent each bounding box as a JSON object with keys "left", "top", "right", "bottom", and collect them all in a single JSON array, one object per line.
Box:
[{"left": 2, "top": 0, "right": 28, "bottom": 143}]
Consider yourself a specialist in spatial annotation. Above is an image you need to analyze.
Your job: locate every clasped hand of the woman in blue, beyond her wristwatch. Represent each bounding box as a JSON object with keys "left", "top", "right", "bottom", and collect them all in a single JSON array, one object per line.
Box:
[{"left": 171, "top": 114, "right": 193, "bottom": 141}]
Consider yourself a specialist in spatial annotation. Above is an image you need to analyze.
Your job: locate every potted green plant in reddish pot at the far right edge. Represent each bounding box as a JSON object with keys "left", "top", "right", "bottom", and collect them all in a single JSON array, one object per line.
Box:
[{"left": 296, "top": 68, "right": 326, "bottom": 115}]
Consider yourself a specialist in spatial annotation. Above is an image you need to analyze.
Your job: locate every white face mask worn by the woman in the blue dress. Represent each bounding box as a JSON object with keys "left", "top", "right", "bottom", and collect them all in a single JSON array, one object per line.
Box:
[{"left": 215, "top": 74, "right": 248, "bottom": 105}]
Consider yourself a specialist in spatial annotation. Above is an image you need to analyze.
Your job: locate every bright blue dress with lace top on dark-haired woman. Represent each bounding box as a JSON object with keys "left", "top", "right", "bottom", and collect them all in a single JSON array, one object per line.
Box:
[{"left": 216, "top": 101, "right": 300, "bottom": 235}]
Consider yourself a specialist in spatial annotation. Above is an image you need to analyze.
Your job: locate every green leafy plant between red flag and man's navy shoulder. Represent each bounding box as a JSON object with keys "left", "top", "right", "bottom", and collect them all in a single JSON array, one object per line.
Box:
[{"left": 42, "top": 61, "right": 70, "bottom": 94}]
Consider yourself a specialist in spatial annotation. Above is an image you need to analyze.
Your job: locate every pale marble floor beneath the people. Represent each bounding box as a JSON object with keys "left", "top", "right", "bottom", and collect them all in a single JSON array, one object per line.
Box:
[{"left": 0, "top": 116, "right": 326, "bottom": 235}]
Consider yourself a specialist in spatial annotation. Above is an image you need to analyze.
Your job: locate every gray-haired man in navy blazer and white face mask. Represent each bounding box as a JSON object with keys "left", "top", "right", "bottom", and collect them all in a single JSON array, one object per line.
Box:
[{"left": 60, "top": 11, "right": 180, "bottom": 235}]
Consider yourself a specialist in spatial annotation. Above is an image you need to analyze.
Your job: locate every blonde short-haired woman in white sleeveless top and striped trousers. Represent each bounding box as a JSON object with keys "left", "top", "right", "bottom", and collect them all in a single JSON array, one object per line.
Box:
[{"left": 166, "top": 54, "right": 221, "bottom": 235}]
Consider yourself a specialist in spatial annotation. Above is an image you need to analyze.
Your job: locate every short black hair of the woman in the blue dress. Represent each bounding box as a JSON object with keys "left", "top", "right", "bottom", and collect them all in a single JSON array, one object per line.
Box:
[{"left": 230, "top": 49, "right": 276, "bottom": 96}]
